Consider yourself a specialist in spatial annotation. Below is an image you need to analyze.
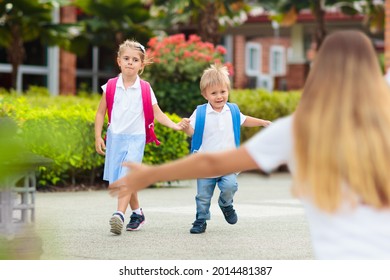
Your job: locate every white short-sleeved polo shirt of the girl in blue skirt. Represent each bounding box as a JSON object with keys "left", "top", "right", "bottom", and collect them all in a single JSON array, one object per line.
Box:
[{"left": 101, "top": 74, "right": 157, "bottom": 134}]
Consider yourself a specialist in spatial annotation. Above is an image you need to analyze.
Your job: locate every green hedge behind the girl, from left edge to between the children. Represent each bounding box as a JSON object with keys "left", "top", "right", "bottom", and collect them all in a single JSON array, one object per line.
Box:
[{"left": 0, "top": 91, "right": 188, "bottom": 186}]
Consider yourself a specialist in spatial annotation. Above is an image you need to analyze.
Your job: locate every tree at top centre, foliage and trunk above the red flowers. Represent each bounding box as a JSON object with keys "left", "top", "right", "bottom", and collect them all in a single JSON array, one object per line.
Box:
[{"left": 151, "top": 0, "right": 250, "bottom": 45}]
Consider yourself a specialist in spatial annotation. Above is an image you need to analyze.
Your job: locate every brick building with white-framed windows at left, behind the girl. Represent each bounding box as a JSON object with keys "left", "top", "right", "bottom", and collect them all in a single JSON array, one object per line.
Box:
[{"left": 0, "top": 6, "right": 111, "bottom": 95}]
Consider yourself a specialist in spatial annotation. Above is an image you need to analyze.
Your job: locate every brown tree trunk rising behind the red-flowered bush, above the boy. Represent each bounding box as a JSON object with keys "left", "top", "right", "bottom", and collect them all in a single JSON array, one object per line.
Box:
[{"left": 198, "top": 3, "right": 221, "bottom": 46}]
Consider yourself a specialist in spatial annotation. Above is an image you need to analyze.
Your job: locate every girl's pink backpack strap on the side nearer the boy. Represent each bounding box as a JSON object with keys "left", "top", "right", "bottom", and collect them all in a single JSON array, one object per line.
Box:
[{"left": 140, "top": 79, "right": 160, "bottom": 146}]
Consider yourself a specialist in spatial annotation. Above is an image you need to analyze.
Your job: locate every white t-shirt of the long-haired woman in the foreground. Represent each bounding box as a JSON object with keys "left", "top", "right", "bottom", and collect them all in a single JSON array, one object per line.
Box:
[{"left": 245, "top": 116, "right": 390, "bottom": 260}]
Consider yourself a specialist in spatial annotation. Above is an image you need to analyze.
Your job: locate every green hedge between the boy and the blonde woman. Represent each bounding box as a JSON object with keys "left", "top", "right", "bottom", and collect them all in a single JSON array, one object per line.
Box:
[{"left": 229, "top": 89, "right": 301, "bottom": 142}]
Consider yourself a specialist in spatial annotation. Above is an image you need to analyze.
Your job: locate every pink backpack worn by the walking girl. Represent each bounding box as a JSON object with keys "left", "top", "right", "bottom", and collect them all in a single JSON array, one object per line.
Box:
[{"left": 106, "top": 77, "right": 160, "bottom": 146}]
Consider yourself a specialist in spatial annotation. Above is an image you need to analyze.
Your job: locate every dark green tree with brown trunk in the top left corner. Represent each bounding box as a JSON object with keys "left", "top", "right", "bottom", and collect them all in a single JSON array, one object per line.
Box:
[{"left": 0, "top": 0, "right": 79, "bottom": 88}]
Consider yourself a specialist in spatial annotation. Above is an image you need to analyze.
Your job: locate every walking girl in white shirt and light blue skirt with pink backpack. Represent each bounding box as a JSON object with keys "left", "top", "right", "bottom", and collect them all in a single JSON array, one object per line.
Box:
[{"left": 95, "top": 40, "right": 188, "bottom": 234}]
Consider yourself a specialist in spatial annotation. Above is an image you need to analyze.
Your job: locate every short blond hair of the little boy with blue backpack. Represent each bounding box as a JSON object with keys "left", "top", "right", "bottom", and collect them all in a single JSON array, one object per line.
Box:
[{"left": 200, "top": 64, "right": 230, "bottom": 94}]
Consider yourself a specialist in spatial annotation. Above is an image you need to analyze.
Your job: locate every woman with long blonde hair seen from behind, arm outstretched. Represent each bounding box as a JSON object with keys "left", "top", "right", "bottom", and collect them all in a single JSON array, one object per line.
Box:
[{"left": 109, "top": 31, "right": 390, "bottom": 259}]
